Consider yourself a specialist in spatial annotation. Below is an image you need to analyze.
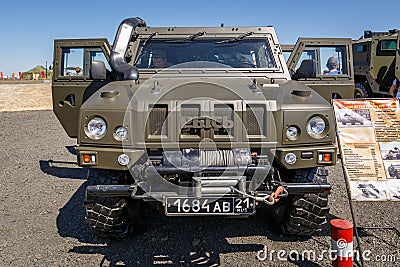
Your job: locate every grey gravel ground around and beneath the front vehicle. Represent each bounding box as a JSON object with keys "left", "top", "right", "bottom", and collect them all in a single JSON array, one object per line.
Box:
[{"left": 0, "top": 111, "right": 400, "bottom": 266}]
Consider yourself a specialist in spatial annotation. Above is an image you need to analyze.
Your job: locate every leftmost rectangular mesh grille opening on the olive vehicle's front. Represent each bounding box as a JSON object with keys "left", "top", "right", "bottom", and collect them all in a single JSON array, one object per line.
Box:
[{"left": 147, "top": 104, "right": 168, "bottom": 135}]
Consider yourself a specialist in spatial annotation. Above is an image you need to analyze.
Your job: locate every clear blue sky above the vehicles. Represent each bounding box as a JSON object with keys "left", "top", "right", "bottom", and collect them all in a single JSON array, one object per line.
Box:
[{"left": 0, "top": 0, "right": 400, "bottom": 74}]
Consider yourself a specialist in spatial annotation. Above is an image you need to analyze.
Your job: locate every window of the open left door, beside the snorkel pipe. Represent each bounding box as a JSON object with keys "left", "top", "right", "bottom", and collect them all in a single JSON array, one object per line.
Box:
[{"left": 60, "top": 48, "right": 111, "bottom": 77}]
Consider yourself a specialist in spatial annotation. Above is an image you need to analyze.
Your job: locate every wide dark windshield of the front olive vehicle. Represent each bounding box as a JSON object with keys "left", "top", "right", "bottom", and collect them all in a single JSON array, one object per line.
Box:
[{"left": 136, "top": 39, "right": 276, "bottom": 69}]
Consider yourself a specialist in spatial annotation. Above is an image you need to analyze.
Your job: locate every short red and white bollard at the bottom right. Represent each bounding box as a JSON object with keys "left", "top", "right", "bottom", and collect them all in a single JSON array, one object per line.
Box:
[{"left": 330, "top": 219, "right": 354, "bottom": 267}]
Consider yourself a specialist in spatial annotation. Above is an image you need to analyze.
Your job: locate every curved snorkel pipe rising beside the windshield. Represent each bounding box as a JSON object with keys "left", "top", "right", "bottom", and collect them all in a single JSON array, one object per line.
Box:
[{"left": 110, "top": 18, "right": 146, "bottom": 80}]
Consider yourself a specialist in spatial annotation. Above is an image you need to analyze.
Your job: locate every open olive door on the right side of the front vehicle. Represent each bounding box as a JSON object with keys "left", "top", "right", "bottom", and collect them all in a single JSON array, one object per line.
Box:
[{"left": 282, "top": 37, "right": 354, "bottom": 101}]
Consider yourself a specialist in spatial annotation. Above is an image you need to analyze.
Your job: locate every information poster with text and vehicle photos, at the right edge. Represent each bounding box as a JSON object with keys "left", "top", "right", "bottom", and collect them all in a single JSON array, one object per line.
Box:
[{"left": 333, "top": 99, "right": 400, "bottom": 201}]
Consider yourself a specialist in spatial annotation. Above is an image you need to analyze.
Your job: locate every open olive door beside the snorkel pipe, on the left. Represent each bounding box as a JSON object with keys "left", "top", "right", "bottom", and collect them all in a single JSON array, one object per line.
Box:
[{"left": 52, "top": 39, "right": 111, "bottom": 137}]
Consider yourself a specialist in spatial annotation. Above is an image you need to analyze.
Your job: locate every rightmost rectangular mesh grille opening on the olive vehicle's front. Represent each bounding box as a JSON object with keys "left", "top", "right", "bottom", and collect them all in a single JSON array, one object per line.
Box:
[{"left": 245, "top": 105, "right": 265, "bottom": 135}]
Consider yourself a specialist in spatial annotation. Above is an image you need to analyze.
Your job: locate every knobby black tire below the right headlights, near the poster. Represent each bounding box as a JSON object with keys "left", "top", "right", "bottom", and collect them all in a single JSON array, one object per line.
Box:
[{"left": 281, "top": 168, "right": 329, "bottom": 235}]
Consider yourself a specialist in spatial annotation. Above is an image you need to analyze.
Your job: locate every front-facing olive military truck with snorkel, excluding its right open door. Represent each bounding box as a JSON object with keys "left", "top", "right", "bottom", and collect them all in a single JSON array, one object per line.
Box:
[{"left": 52, "top": 18, "right": 336, "bottom": 236}]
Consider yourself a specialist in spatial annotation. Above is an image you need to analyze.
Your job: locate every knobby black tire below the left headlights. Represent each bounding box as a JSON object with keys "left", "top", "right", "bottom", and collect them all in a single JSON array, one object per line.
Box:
[{"left": 85, "top": 169, "right": 133, "bottom": 237}]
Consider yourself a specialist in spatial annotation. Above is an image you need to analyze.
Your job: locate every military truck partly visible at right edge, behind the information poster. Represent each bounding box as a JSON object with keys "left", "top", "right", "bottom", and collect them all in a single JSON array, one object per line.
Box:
[{"left": 353, "top": 30, "right": 400, "bottom": 98}]
